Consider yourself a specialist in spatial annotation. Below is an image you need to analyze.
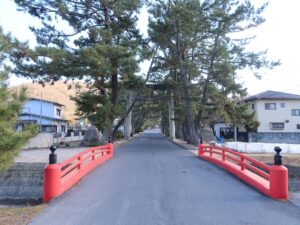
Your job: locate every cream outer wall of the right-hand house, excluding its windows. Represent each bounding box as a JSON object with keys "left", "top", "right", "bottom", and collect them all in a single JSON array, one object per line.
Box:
[{"left": 254, "top": 100, "right": 300, "bottom": 133}]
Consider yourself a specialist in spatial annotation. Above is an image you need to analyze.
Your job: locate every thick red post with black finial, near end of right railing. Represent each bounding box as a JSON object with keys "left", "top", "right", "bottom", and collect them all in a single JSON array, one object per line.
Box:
[{"left": 270, "top": 147, "right": 289, "bottom": 200}]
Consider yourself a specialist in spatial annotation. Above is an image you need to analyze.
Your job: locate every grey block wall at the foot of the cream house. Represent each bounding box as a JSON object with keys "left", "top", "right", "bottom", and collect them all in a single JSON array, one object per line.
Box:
[{"left": 248, "top": 132, "right": 300, "bottom": 144}]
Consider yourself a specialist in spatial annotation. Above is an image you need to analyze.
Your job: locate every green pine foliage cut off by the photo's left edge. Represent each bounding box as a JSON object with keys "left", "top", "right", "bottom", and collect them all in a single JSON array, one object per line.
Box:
[{"left": 0, "top": 27, "right": 37, "bottom": 170}]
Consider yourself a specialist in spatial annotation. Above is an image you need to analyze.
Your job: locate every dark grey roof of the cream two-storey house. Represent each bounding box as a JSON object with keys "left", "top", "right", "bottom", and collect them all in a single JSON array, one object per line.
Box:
[{"left": 244, "top": 91, "right": 300, "bottom": 102}]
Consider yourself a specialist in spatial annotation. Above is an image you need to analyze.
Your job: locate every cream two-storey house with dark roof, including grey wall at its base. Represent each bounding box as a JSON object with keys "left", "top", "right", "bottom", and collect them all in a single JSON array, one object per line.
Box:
[{"left": 244, "top": 91, "right": 300, "bottom": 143}]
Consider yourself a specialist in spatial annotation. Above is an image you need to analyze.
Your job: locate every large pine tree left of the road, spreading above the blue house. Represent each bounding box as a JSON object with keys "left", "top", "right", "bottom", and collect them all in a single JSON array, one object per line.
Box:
[{"left": 15, "top": 0, "right": 147, "bottom": 142}]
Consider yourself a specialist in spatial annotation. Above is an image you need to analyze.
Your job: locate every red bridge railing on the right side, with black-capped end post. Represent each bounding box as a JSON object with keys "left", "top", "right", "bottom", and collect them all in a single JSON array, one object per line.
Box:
[{"left": 198, "top": 144, "right": 288, "bottom": 200}]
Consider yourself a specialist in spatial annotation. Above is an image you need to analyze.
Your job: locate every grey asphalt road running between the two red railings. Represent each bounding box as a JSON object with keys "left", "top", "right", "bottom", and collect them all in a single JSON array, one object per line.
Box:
[{"left": 30, "top": 133, "right": 300, "bottom": 225}]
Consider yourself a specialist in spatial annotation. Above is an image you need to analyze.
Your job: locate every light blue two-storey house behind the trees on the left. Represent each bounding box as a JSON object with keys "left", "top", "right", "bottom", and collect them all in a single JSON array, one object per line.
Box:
[{"left": 17, "top": 98, "right": 68, "bottom": 133}]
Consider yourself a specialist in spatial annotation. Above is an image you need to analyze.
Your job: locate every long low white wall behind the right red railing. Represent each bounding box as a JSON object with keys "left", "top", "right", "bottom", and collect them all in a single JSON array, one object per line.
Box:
[{"left": 225, "top": 142, "right": 300, "bottom": 154}]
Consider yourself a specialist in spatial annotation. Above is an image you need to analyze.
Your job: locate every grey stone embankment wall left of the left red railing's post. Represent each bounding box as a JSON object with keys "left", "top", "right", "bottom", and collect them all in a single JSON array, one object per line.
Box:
[{"left": 0, "top": 163, "right": 46, "bottom": 201}]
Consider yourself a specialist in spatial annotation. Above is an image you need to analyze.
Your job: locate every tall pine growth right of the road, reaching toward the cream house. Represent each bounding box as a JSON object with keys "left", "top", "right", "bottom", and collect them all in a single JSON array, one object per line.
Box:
[{"left": 149, "top": 0, "right": 277, "bottom": 144}]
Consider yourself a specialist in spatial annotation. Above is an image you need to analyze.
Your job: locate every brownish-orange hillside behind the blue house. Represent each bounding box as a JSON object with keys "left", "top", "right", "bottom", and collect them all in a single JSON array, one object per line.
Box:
[{"left": 11, "top": 81, "right": 87, "bottom": 123}]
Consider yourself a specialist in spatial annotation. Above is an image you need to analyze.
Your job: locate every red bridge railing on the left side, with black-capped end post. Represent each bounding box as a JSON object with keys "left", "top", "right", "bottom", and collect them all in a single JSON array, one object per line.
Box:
[{"left": 43, "top": 144, "right": 114, "bottom": 202}]
